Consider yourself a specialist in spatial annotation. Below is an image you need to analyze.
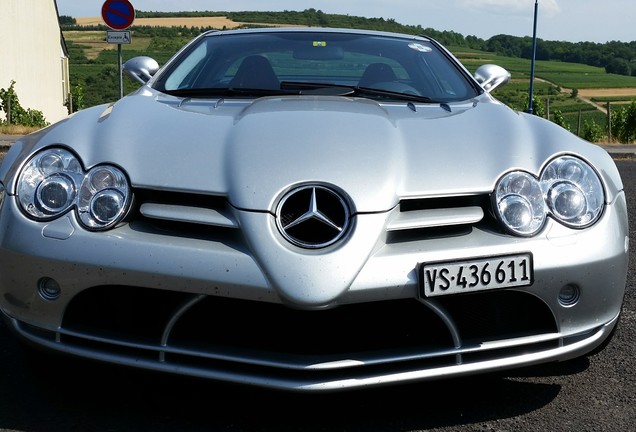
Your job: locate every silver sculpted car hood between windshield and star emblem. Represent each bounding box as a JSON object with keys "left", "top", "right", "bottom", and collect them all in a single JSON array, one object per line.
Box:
[{"left": 6, "top": 87, "right": 612, "bottom": 212}]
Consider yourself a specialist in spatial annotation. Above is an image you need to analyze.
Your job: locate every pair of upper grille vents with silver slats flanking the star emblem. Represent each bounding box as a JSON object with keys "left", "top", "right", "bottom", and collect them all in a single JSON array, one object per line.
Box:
[{"left": 128, "top": 189, "right": 502, "bottom": 244}]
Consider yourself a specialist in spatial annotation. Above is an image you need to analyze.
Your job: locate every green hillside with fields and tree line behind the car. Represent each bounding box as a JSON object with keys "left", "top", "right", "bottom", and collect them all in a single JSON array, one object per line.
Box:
[{"left": 61, "top": 9, "right": 636, "bottom": 142}]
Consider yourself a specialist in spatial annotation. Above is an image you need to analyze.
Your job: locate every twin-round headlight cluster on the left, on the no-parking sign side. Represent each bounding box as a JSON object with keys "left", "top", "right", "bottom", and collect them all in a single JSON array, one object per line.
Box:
[{"left": 17, "top": 148, "right": 130, "bottom": 230}]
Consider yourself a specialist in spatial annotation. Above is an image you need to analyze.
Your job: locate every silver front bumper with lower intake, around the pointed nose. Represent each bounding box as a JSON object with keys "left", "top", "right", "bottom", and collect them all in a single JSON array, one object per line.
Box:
[{"left": 0, "top": 190, "right": 628, "bottom": 391}]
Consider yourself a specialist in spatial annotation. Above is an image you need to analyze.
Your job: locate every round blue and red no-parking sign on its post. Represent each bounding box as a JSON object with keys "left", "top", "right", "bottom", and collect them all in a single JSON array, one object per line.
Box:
[{"left": 102, "top": 0, "right": 135, "bottom": 99}]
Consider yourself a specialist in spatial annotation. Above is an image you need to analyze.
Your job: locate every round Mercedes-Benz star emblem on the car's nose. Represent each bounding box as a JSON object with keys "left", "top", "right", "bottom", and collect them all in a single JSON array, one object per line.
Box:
[{"left": 276, "top": 185, "right": 350, "bottom": 249}]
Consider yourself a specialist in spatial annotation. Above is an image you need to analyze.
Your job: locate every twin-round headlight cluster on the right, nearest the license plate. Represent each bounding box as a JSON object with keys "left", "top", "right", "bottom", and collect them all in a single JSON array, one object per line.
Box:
[{"left": 494, "top": 156, "right": 605, "bottom": 236}]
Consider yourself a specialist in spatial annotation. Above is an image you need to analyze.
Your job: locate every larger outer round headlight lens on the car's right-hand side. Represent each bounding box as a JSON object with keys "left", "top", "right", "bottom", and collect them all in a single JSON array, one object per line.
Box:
[{"left": 541, "top": 156, "right": 605, "bottom": 228}]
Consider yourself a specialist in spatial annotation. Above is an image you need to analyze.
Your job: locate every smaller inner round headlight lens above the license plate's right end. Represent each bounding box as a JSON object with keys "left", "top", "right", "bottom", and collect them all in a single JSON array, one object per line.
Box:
[{"left": 495, "top": 171, "right": 546, "bottom": 236}]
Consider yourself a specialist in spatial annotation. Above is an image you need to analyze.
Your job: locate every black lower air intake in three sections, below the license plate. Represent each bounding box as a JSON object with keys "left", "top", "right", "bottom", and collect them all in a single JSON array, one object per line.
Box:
[{"left": 62, "top": 286, "right": 556, "bottom": 356}]
